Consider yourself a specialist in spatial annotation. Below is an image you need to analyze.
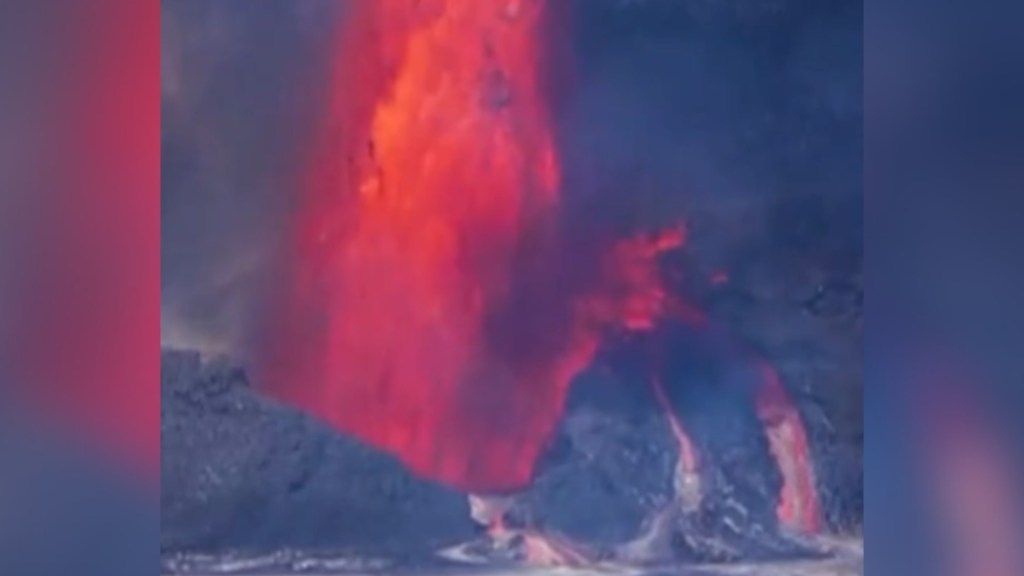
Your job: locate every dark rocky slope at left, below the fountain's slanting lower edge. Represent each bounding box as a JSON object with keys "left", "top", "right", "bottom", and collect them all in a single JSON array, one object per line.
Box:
[{"left": 161, "top": 352, "right": 475, "bottom": 557}]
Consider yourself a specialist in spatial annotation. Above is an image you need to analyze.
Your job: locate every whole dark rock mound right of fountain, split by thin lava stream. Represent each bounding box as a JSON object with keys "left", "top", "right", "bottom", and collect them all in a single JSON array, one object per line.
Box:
[{"left": 513, "top": 329, "right": 807, "bottom": 562}]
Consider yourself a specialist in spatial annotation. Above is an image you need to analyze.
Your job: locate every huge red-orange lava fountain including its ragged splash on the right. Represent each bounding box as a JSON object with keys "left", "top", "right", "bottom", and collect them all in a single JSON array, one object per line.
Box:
[{"left": 266, "top": 0, "right": 819, "bottom": 532}]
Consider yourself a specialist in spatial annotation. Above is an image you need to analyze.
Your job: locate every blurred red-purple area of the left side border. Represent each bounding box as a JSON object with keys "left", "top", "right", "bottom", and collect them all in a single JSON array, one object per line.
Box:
[{"left": 3, "top": 0, "right": 161, "bottom": 483}]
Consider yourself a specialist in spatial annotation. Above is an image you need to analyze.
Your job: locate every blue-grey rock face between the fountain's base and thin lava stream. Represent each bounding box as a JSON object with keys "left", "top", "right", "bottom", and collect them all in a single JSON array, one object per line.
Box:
[{"left": 519, "top": 372, "right": 678, "bottom": 546}]
